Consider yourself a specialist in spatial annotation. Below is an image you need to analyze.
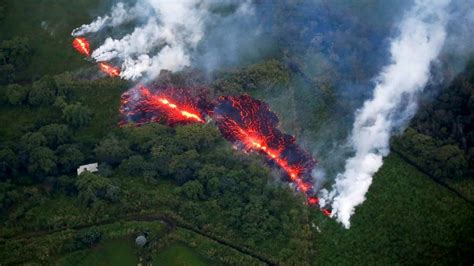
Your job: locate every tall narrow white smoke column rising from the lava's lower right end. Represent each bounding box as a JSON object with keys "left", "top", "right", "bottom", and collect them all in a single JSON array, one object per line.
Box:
[{"left": 322, "top": 0, "right": 449, "bottom": 228}]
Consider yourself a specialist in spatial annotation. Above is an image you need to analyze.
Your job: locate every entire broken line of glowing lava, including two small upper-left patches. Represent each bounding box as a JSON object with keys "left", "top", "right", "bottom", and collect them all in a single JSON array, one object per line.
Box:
[{"left": 73, "top": 34, "right": 331, "bottom": 216}]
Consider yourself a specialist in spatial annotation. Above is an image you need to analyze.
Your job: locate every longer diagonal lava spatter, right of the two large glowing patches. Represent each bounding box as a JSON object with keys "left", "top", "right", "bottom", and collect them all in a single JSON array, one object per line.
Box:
[{"left": 212, "top": 95, "right": 316, "bottom": 197}]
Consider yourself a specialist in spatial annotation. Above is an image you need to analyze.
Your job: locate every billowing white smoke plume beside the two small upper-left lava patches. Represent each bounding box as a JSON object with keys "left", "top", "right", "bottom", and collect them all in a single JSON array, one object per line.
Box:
[{"left": 72, "top": 0, "right": 253, "bottom": 80}]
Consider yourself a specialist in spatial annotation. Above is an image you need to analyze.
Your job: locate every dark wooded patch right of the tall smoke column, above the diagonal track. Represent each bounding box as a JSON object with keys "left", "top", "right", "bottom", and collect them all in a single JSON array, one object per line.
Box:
[{"left": 393, "top": 61, "right": 474, "bottom": 201}]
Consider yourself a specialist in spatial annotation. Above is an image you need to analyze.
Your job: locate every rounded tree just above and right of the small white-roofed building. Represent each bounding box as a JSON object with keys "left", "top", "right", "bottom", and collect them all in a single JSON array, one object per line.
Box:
[{"left": 95, "top": 136, "right": 132, "bottom": 164}]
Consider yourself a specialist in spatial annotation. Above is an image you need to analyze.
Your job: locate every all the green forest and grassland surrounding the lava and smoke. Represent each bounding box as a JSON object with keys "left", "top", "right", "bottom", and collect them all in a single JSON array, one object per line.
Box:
[{"left": 0, "top": 0, "right": 474, "bottom": 265}]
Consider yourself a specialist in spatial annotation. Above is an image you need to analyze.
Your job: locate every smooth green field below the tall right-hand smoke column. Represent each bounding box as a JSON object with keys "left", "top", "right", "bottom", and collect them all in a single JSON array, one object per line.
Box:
[{"left": 316, "top": 154, "right": 474, "bottom": 264}]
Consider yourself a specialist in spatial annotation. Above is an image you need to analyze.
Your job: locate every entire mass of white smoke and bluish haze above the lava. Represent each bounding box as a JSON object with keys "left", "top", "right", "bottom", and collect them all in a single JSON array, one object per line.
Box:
[{"left": 72, "top": 0, "right": 474, "bottom": 227}]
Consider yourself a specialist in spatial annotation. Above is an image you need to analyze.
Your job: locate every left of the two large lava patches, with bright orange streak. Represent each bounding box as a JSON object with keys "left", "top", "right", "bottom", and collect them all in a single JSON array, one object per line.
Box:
[{"left": 120, "top": 86, "right": 205, "bottom": 126}]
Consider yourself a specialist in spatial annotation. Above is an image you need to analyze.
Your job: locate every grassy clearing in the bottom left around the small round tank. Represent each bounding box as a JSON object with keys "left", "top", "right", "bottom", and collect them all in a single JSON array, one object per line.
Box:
[{"left": 0, "top": 221, "right": 165, "bottom": 265}]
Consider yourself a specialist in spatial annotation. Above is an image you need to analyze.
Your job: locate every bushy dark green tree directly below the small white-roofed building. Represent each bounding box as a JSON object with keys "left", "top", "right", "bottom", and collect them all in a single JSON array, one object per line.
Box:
[{"left": 76, "top": 171, "right": 120, "bottom": 206}]
